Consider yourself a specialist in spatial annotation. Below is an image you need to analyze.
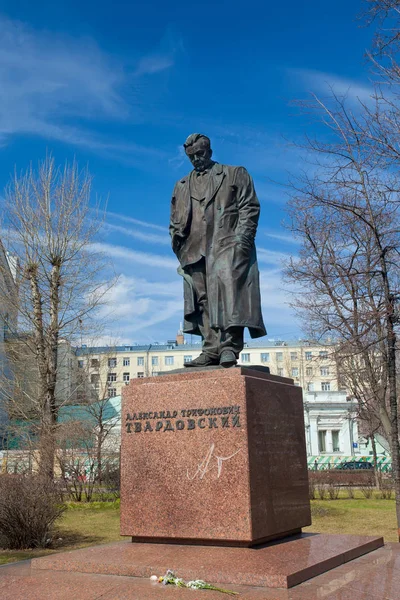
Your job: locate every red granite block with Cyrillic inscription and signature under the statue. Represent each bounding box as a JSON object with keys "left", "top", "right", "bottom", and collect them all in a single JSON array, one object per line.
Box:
[{"left": 121, "top": 367, "right": 311, "bottom": 547}]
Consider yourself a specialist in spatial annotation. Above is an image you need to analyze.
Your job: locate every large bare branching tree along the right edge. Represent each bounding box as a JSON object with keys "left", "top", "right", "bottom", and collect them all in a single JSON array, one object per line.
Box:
[{"left": 287, "top": 91, "right": 400, "bottom": 537}]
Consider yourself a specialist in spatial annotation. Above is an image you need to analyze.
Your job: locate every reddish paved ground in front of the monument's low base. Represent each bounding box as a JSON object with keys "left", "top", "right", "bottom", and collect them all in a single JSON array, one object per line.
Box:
[{"left": 0, "top": 544, "right": 400, "bottom": 600}]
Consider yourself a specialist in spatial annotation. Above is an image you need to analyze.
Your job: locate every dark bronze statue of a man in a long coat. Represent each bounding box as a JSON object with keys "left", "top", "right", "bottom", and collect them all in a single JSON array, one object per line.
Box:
[{"left": 169, "top": 133, "right": 266, "bottom": 367}]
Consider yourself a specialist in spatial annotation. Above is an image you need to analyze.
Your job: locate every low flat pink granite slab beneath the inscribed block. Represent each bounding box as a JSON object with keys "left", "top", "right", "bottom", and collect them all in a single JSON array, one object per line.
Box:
[{"left": 32, "top": 534, "right": 383, "bottom": 588}]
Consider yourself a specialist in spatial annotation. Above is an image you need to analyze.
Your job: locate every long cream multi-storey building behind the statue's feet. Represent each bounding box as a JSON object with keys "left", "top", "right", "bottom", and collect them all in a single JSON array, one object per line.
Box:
[{"left": 76, "top": 338, "right": 338, "bottom": 397}]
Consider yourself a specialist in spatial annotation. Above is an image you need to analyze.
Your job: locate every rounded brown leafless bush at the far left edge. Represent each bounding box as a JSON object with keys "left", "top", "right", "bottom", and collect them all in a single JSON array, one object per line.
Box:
[{"left": 0, "top": 475, "right": 65, "bottom": 550}]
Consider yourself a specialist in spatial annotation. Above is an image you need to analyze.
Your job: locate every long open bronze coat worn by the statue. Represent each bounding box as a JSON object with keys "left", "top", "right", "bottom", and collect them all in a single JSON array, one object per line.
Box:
[{"left": 170, "top": 163, "right": 266, "bottom": 338}]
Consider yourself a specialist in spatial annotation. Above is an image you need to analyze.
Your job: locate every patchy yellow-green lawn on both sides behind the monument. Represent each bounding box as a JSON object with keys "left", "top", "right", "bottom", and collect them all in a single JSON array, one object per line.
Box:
[{"left": 0, "top": 498, "right": 397, "bottom": 564}]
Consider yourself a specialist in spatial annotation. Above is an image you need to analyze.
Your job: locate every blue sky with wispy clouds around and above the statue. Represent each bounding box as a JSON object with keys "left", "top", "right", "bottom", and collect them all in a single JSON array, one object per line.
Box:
[{"left": 0, "top": 0, "right": 372, "bottom": 343}]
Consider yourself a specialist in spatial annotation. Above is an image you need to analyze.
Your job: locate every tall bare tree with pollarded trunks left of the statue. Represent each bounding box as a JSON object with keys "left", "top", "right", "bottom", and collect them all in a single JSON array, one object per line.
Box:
[{"left": 0, "top": 158, "right": 113, "bottom": 478}]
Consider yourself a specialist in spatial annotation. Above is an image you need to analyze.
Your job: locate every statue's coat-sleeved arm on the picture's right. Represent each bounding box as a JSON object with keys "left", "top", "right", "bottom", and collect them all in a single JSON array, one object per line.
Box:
[{"left": 235, "top": 167, "right": 260, "bottom": 250}]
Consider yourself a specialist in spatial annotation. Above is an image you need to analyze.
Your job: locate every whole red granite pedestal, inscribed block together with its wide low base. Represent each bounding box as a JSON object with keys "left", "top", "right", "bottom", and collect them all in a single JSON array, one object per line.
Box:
[{"left": 27, "top": 367, "right": 384, "bottom": 600}]
